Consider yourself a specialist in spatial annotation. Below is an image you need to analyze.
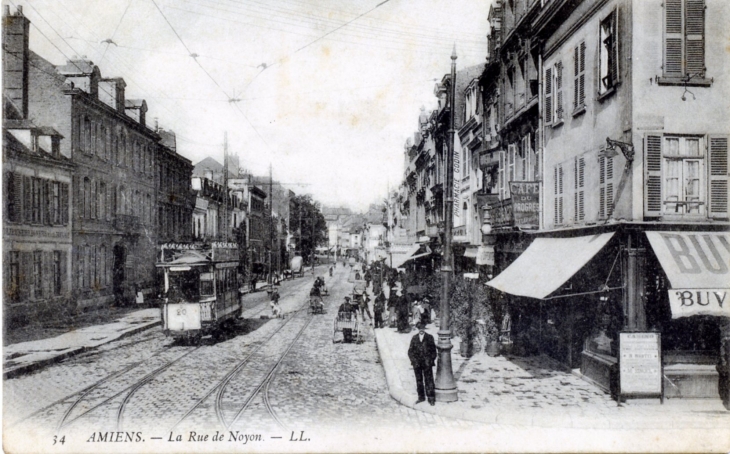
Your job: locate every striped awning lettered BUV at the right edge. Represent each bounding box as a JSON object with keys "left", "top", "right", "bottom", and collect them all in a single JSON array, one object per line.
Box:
[{"left": 646, "top": 232, "right": 730, "bottom": 318}]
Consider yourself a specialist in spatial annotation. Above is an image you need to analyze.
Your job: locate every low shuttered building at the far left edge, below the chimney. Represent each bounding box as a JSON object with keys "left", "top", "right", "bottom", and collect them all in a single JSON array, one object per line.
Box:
[{"left": 3, "top": 98, "right": 74, "bottom": 329}]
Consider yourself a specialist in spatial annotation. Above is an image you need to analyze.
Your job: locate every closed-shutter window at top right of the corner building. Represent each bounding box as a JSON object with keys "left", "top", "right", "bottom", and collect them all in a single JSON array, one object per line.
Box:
[{"left": 664, "top": 0, "right": 705, "bottom": 79}]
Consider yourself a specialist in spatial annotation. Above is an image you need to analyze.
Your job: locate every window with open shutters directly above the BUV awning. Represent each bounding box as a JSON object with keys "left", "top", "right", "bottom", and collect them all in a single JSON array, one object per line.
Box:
[{"left": 644, "top": 135, "right": 728, "bottom": 219}]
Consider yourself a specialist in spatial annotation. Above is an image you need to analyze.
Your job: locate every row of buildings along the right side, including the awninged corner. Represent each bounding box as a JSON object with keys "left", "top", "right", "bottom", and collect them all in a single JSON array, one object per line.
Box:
[{"left": 388, "top": 0, "right": 730, "bottom": 404}]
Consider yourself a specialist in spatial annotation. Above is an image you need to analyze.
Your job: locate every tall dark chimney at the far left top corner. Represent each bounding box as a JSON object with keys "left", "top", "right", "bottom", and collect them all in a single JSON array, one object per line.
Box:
[{"left": 2, "top": 5, "right": 30, "bottom": 119}]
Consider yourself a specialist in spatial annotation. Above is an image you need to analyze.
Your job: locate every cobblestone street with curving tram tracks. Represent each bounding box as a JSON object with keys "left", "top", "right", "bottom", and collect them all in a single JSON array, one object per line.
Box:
[{"left": 4, "top": 269, "right": 476, "bottom": 450}]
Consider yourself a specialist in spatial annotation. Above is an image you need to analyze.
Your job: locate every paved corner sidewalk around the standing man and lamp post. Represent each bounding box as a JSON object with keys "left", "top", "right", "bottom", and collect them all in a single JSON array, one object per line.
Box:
[{"left": 375, "top": 325, "right": 730, "bottom": 433}]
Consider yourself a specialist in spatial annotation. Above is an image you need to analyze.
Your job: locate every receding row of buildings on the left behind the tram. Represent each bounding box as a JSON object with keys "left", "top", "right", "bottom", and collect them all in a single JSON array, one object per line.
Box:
[{"left": 2, "top": 6, "right": 286, "bottom": 329}]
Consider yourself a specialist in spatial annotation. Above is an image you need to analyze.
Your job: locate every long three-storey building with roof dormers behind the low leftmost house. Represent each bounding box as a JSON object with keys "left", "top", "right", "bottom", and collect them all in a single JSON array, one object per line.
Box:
[{"left": 4, "top": 5, "right": 192, "bottom": 308}]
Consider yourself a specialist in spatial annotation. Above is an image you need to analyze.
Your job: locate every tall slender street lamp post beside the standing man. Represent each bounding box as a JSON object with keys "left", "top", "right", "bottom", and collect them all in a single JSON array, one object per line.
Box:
[{"left": 435, "top": 45, "right": 459, "bottom": 402}]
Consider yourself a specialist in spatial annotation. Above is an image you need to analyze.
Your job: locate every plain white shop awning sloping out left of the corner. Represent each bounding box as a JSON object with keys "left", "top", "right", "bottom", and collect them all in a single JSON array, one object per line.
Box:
[{"left": 487, "top": 232, "right": 614, "bottom": 299}]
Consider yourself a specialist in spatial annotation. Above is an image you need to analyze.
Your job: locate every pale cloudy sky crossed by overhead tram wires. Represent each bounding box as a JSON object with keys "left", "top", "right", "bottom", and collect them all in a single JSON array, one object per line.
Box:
[{"left": 17, "top": 0, "right": 490, "bottom": 211}]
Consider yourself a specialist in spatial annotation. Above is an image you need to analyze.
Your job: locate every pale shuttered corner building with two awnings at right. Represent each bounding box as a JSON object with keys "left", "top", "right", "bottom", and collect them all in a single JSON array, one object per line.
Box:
[{"left": 489, "top": 0, "right": 730, "bottom": 405}]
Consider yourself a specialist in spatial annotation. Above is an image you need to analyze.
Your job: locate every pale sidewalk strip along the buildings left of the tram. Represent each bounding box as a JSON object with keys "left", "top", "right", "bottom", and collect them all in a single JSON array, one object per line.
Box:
[{"left": 3, "top": 309, "right": 161, "bottom": 379}]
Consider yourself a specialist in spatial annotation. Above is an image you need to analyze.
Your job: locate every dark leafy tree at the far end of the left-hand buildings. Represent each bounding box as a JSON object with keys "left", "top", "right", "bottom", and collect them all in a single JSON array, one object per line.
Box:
[{"left": 289, "top": 195, "right": 327, "bottom": 260}]
